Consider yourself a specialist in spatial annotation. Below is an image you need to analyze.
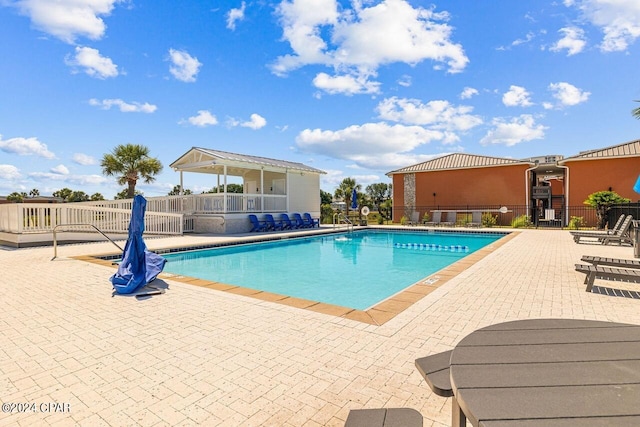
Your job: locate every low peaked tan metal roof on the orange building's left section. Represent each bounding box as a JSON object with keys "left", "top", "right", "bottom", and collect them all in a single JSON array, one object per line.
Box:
[{"left": 387, "top": 153, "right": 533, "bottom": 175}]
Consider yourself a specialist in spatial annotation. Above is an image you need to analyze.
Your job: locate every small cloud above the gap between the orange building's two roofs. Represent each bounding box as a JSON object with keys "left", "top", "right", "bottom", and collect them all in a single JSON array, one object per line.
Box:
[{"left": 480, "top": 114, "right": 547, "bottom": 147}]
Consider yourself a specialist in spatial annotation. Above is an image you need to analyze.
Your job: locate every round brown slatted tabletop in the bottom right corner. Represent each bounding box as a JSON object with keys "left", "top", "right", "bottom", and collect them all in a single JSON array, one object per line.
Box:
[{"left": 450, "top": 319, "right": 640, "bottom": 427}]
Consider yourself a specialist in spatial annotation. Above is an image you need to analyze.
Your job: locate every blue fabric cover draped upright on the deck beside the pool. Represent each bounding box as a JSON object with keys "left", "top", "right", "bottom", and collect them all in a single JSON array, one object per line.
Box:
[{"left": 109, "top": 195, "right": 167, "bottom": 294}]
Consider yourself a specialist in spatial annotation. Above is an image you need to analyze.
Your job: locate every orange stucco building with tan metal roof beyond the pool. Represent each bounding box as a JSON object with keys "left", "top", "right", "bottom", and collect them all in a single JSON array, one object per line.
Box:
[{"left": 387, "top": 140, "right": 640, "bottom": 225}]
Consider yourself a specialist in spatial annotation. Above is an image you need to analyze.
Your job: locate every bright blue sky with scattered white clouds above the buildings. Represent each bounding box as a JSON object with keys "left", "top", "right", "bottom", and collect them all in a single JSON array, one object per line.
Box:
[{"left": 0, "top": 0, "right": 640, "bottom": 199}]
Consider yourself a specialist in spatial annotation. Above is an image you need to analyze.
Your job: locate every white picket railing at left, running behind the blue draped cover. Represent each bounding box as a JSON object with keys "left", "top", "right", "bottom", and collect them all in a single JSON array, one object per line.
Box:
[{"left": 0, "top": 201, "right": 184, "bottom": 234}]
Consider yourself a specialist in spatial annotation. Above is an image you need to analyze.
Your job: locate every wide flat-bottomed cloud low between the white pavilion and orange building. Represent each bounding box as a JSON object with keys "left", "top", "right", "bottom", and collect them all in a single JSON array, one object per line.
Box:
[{"left": 296, "top": 122, "right": 445, "bottom": 170}]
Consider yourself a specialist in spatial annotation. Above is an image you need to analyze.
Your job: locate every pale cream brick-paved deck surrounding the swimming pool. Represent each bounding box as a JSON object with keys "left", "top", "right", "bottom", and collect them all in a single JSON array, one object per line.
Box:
[{"left": 0, "top": 226, "right": 640, "bottom": 426}]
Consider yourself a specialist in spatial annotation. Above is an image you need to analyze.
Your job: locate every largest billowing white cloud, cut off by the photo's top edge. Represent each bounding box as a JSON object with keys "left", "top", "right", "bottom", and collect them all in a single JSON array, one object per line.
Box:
[{"left": 272, "top": 0, "right": 469, "bottom": 93}]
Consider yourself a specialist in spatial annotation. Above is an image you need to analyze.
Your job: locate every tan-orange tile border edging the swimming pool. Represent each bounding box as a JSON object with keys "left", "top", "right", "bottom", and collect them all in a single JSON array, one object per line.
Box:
[{"left": 73, "top": 231, "right": 520, "bottom": 326}]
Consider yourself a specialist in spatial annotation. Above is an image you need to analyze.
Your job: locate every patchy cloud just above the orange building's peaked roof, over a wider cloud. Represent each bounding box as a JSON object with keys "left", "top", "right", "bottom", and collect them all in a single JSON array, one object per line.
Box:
[{"left": 376, "top": 97, "right": 482, "bottom": 143}]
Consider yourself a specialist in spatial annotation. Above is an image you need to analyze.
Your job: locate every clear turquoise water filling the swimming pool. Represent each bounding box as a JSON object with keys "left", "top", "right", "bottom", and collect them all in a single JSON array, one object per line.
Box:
[{"left": 163, "top": 230, "right": 504, "bottom": 310}]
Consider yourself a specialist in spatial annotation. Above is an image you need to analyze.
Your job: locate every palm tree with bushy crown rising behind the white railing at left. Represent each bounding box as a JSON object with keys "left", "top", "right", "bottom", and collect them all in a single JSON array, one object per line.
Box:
[{"left": 100, "top": 144, "right": 162, "bottom": 198}]
